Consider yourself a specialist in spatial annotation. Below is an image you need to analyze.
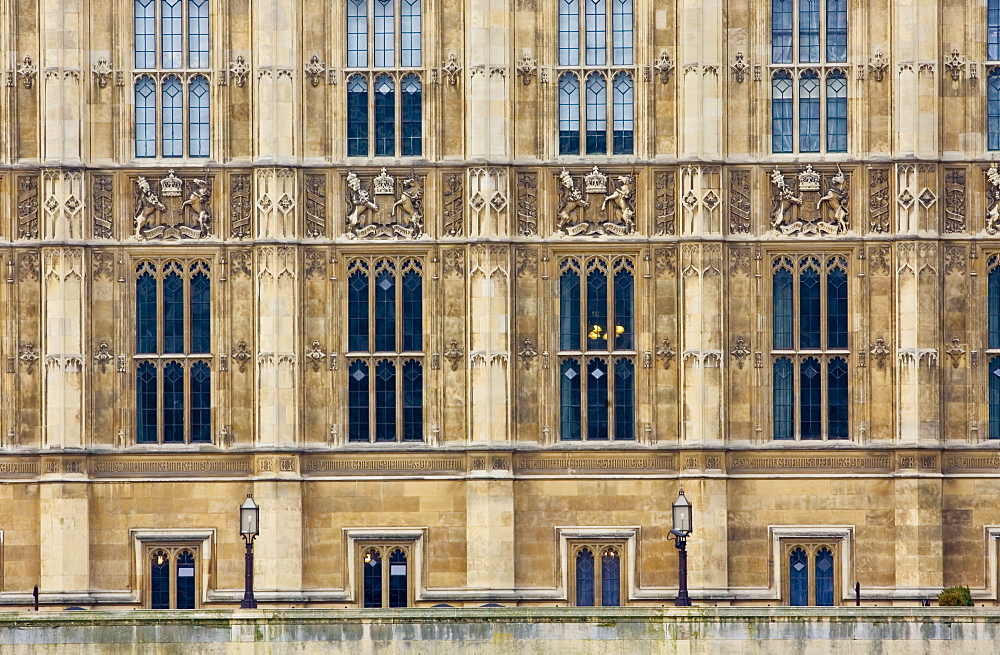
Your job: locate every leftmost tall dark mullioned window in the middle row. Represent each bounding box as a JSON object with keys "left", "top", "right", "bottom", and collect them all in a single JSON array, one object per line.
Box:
[{"left": 134, "top": 261, "right": 212, "bottom": 444}]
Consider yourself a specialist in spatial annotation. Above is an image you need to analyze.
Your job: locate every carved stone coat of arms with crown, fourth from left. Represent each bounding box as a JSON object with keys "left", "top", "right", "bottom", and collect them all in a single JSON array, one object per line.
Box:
[{"left": 771, "top": 166, "right": 849, "bottom": 236}]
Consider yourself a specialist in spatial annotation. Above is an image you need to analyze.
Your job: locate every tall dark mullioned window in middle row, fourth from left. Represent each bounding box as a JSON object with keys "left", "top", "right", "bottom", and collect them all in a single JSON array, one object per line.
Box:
[{"left": 771, "top": 255, "right": 850, "bottom": 440}]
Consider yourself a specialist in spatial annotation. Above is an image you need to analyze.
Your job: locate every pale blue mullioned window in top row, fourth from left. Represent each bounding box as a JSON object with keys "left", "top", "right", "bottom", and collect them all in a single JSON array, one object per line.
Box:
[{"left": 771, "top": 0, "right": 848, "bottom": 153}]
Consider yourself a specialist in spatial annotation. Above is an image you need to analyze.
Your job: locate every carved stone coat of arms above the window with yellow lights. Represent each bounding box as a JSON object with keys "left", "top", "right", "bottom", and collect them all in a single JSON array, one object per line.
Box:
[{"left": 558, "top": 166, "right": 635, "bottom": 236}]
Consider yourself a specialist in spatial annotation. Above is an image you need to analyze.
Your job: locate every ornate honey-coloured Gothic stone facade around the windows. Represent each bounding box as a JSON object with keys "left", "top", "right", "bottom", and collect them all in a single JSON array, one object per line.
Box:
[{"left": 0, "top": 0, "right": 1000, "bottom": 608}]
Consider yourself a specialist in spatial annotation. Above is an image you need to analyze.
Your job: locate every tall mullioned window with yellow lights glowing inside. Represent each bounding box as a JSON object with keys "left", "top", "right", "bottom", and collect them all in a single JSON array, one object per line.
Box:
[{"left": 559, "top": 257, "right": 636, "bottom": 441}]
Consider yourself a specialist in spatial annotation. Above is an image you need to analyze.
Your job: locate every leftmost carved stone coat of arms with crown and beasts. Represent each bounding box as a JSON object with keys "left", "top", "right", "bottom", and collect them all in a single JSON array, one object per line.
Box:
[{"left": 133, "top": 171, "right": 212, "bottom": 241}]
